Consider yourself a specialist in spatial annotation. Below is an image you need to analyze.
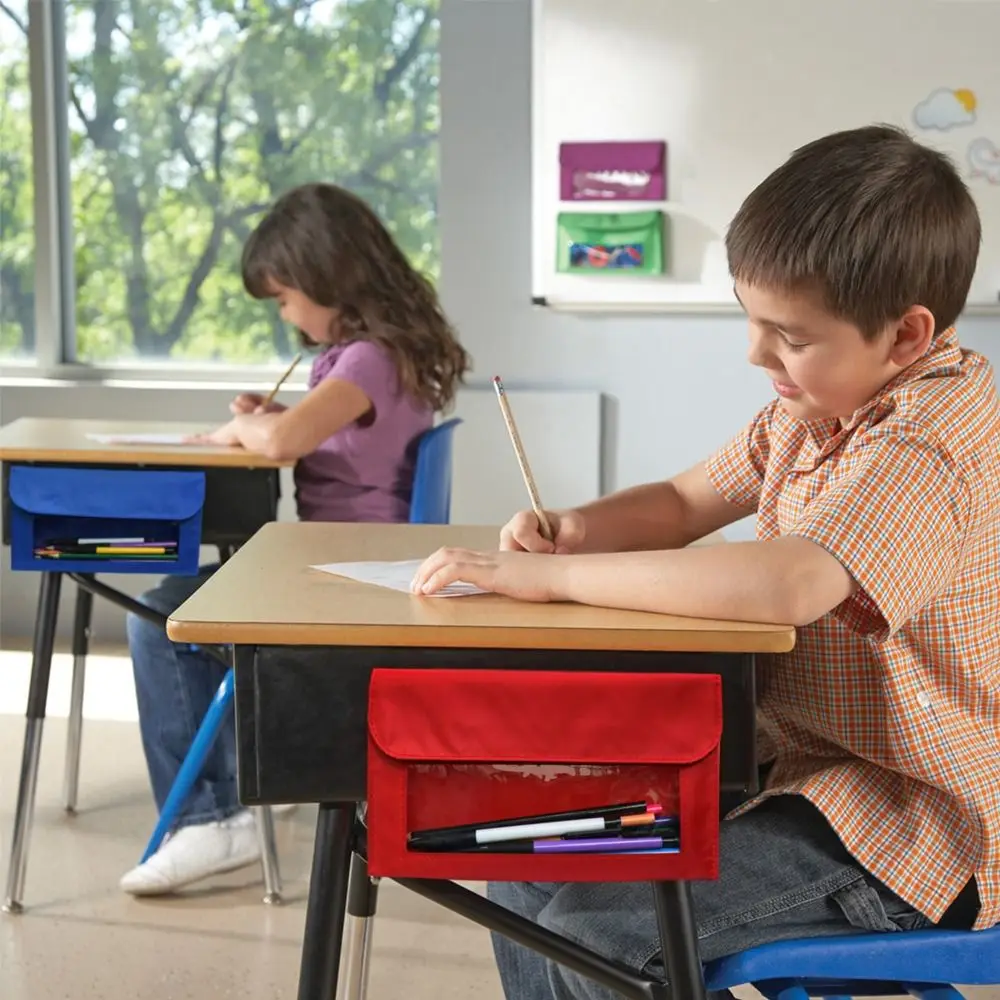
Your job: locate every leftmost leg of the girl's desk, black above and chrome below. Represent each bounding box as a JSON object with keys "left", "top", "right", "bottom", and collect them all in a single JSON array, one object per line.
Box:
[{"left": 3, "top": 573, "right": 62, "bottom": 913}]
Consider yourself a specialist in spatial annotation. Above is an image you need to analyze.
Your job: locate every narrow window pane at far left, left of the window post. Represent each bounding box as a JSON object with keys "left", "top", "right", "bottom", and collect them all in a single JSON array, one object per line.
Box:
[{"left": 0, "top": 0, "right": 35, "bottom": 359}]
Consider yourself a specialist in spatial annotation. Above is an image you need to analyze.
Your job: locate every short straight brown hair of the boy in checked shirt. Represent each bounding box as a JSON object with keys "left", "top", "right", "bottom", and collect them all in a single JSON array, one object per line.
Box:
[{"left": 726, "top": 125, "right": 981, "bottom": 339}]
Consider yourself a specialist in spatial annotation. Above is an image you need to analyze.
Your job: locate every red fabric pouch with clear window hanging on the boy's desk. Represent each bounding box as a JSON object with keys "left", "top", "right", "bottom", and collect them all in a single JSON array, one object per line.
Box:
[{"left": 367, "top": 669, "right": 722, "bottom": 882}]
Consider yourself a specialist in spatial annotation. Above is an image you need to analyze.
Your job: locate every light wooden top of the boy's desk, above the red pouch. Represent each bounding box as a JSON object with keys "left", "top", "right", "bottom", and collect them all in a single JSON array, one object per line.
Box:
[{"left": 167, "top": 522, "right": 795, "bottom": 653}]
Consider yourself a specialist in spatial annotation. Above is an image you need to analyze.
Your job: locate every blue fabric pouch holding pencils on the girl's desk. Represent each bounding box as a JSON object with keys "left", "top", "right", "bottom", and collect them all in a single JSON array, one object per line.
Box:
[{"left": 8, "top": 465, "right": 205, "bottom": 574}]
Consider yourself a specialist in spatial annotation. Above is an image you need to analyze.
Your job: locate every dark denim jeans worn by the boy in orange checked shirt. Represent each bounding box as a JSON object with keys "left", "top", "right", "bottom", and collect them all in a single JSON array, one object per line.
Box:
[{"left": 489, "top": 796, "right": 930, "bottom": 1000}]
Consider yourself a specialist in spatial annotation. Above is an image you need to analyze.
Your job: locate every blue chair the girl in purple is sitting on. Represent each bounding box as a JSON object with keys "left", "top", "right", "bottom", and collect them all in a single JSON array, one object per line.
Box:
[{"left": 142, "top": 417, "right": 462, "bottom": 864}]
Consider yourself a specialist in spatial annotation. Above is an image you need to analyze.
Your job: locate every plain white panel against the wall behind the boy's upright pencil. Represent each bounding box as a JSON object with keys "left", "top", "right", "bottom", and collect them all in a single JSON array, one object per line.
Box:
[{"left": 451, "top": 385, "right": 601, "bottom": 524}]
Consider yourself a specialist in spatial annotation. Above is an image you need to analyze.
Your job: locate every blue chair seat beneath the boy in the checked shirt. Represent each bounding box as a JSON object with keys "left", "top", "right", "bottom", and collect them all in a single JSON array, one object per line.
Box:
[{"left": 705, "top": 927, "right": 1000, "bottom": 1000}]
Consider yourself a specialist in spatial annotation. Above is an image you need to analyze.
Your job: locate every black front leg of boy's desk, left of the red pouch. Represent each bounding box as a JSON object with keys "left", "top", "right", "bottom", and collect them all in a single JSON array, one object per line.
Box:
[{"left": 298, "top": 802, "right": 355, "bottom": 1000}]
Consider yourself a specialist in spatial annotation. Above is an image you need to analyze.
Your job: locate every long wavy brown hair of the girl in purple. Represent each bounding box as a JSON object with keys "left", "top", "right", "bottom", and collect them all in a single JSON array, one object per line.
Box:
[{"left": 243, "top": 184, "right": 470, "bottom": 410}]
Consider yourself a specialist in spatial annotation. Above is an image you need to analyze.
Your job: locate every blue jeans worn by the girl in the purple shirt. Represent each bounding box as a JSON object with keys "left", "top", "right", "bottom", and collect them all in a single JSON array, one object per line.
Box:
[{"left": 126, "top": 566, "right": 242, "bottom": 827}]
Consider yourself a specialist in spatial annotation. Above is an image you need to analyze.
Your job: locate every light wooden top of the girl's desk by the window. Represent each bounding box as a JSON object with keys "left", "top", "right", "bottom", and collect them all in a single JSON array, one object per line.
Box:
[{"left": 0, "top": 417, "right": 293, "bottom": 469}]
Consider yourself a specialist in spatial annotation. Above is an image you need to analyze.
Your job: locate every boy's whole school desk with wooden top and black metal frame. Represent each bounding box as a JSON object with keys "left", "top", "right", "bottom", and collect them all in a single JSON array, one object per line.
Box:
[{"left": 167, "top": 524, "right": 795, "bottom": 1000}]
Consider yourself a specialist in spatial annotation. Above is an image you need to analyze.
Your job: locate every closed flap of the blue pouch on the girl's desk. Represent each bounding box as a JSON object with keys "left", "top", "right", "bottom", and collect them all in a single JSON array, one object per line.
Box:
[{"left": 9, "top": 465, "right": 205, "bottom": 521}]
